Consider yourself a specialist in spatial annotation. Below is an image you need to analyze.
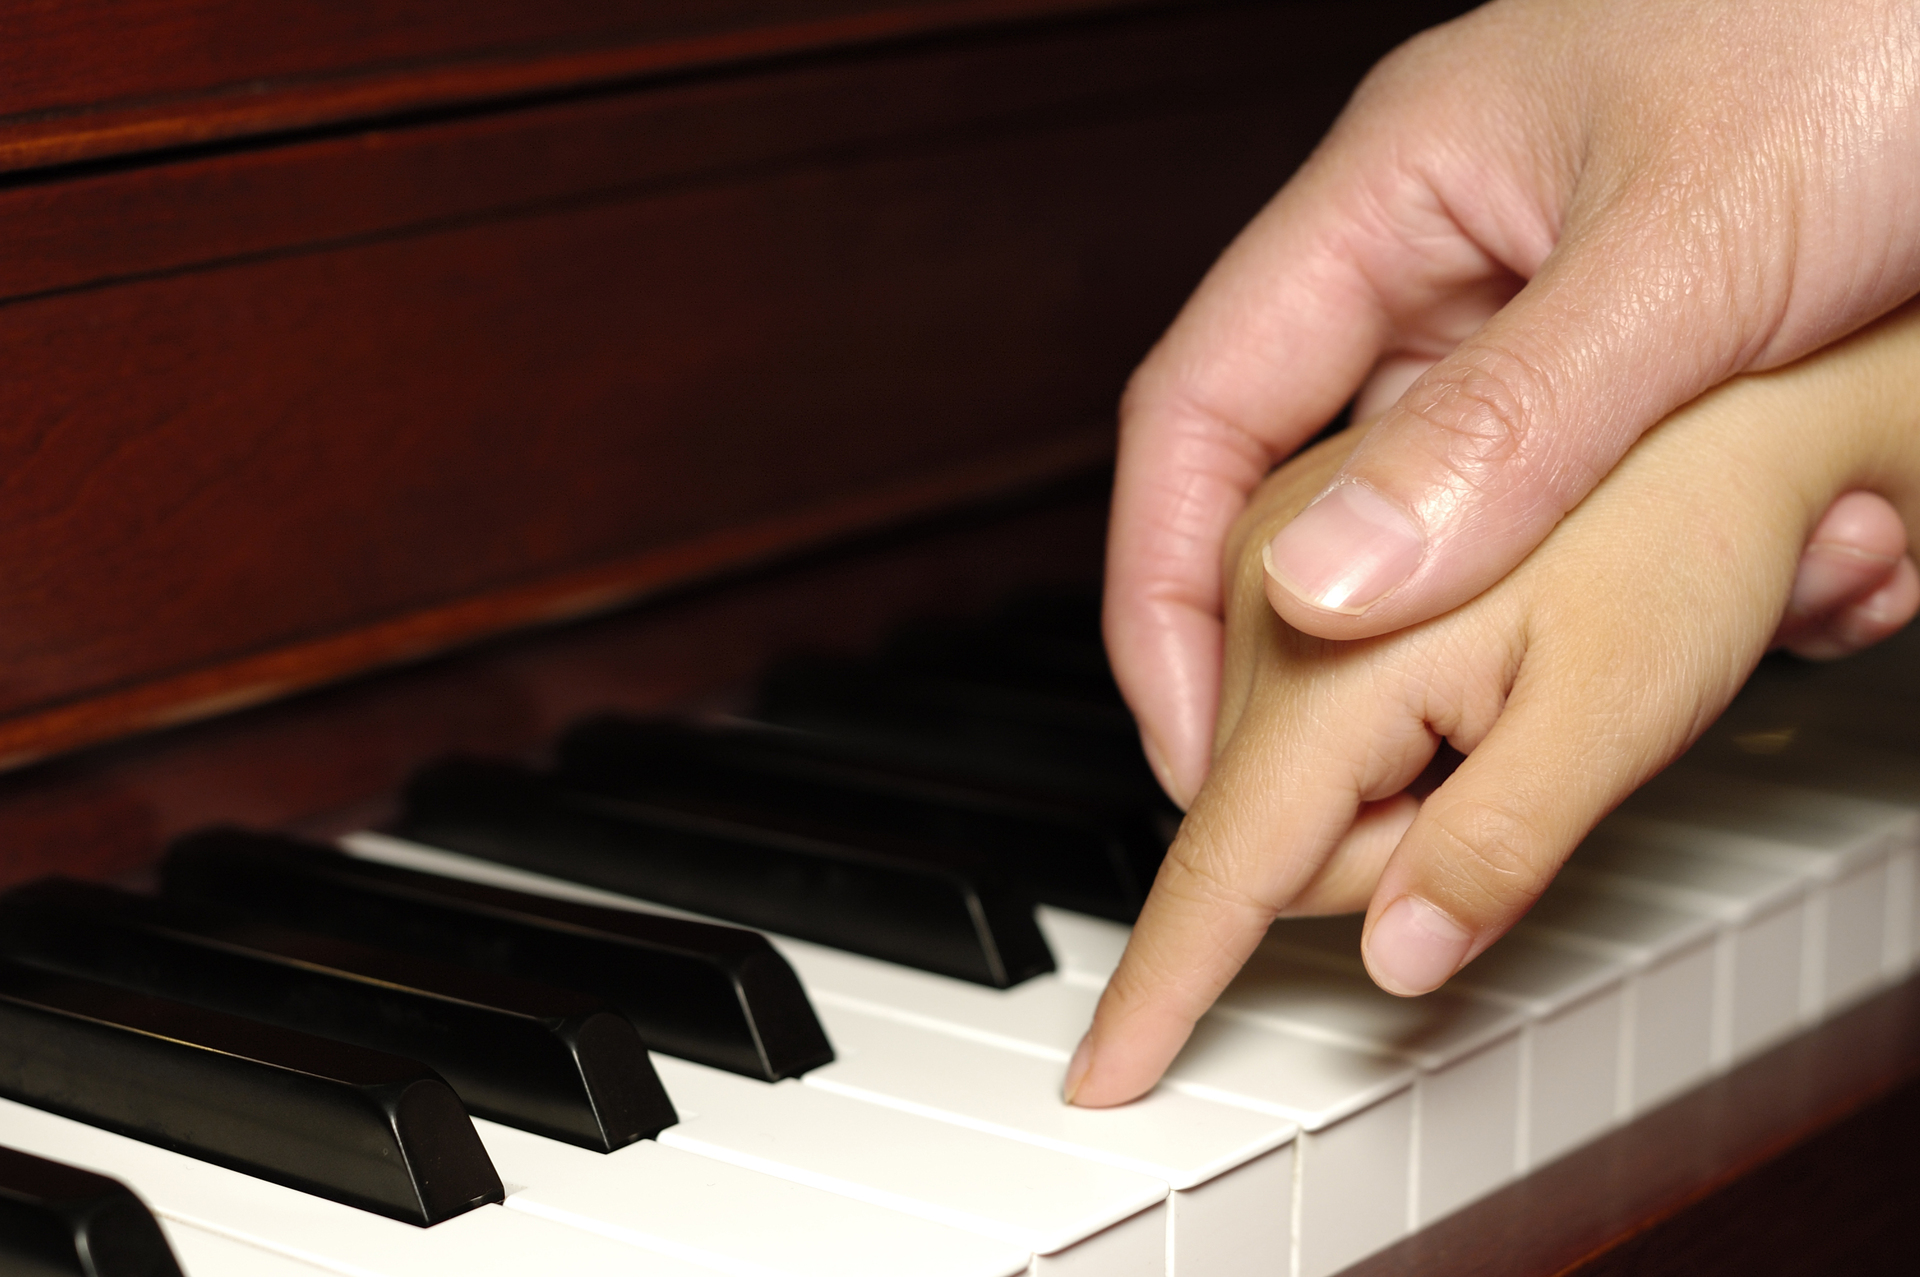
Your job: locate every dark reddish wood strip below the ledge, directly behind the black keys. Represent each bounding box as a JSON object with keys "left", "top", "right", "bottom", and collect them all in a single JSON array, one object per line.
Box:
[{"left": 0, "top": 474, "right": 1106, "bottom": 885}]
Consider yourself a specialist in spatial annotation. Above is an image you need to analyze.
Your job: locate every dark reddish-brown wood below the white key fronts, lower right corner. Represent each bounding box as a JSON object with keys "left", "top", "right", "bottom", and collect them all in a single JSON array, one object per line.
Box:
[{"left": 1342, "top": 977, "right": 1920, "bottom": 1277}]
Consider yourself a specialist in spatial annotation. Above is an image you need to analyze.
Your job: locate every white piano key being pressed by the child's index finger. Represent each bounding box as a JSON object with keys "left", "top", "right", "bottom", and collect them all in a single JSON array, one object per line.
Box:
[{"left": 801, "top": 1002, "right": 1297, "bottom": 1277}]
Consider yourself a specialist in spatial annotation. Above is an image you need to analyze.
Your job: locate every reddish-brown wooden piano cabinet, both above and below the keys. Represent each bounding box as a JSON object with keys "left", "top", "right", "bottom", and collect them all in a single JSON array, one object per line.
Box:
[{"left": 0, "top": 0, "right": 1920, "bottom": 1277}]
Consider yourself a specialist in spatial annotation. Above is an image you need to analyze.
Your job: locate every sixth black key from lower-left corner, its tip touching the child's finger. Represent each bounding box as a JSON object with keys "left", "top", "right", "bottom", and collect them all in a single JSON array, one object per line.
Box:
[{"left": 557, "top": 718, "right": 1165, "bottom": 922}]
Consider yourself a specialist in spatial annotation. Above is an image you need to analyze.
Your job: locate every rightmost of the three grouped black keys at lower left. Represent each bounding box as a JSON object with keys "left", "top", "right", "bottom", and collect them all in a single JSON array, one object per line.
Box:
[{"left": 161, "top": 830, "right": 833, "bottom": 1081}]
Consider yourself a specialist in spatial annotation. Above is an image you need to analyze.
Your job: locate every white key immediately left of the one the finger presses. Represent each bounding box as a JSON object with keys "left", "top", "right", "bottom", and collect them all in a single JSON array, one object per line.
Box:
[{"left": 645, "top": 1060, "right": 1167, "bottom": 1273}]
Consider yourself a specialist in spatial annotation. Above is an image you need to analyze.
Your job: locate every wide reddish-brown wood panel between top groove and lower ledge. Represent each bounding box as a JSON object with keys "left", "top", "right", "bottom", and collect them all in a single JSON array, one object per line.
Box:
[{"left": 0, "top": 6, "right": 1446, "bottom": 764}]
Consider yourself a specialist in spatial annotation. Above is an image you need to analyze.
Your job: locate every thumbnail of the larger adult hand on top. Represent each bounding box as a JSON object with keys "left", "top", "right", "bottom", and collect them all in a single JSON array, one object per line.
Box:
[{"left": 1261, "top": 484, "right": 1427, "bottom": 616}]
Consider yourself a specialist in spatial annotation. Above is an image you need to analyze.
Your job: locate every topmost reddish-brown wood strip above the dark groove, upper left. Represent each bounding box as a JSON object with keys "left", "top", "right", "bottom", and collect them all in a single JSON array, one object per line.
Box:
[{"left": 0, "top": 0, "right": 1173, "bottom": 171}]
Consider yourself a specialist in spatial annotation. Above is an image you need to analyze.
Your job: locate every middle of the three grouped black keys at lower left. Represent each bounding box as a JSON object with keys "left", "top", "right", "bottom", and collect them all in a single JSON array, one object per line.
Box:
[{"left": 0, "top": 878, "right": 676, "bottom": 1152}]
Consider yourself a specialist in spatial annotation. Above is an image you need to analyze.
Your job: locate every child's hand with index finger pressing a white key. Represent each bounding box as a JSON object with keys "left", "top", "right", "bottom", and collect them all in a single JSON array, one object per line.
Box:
[{"left": 1068, "top": 293, "right": 1920, "bottom": 1104}]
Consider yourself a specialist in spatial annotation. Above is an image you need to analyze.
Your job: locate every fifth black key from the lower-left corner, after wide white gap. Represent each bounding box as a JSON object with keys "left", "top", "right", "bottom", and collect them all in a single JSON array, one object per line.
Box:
[{"left": 399, "top": 760, "right": 1054, "bottom": 989}]
